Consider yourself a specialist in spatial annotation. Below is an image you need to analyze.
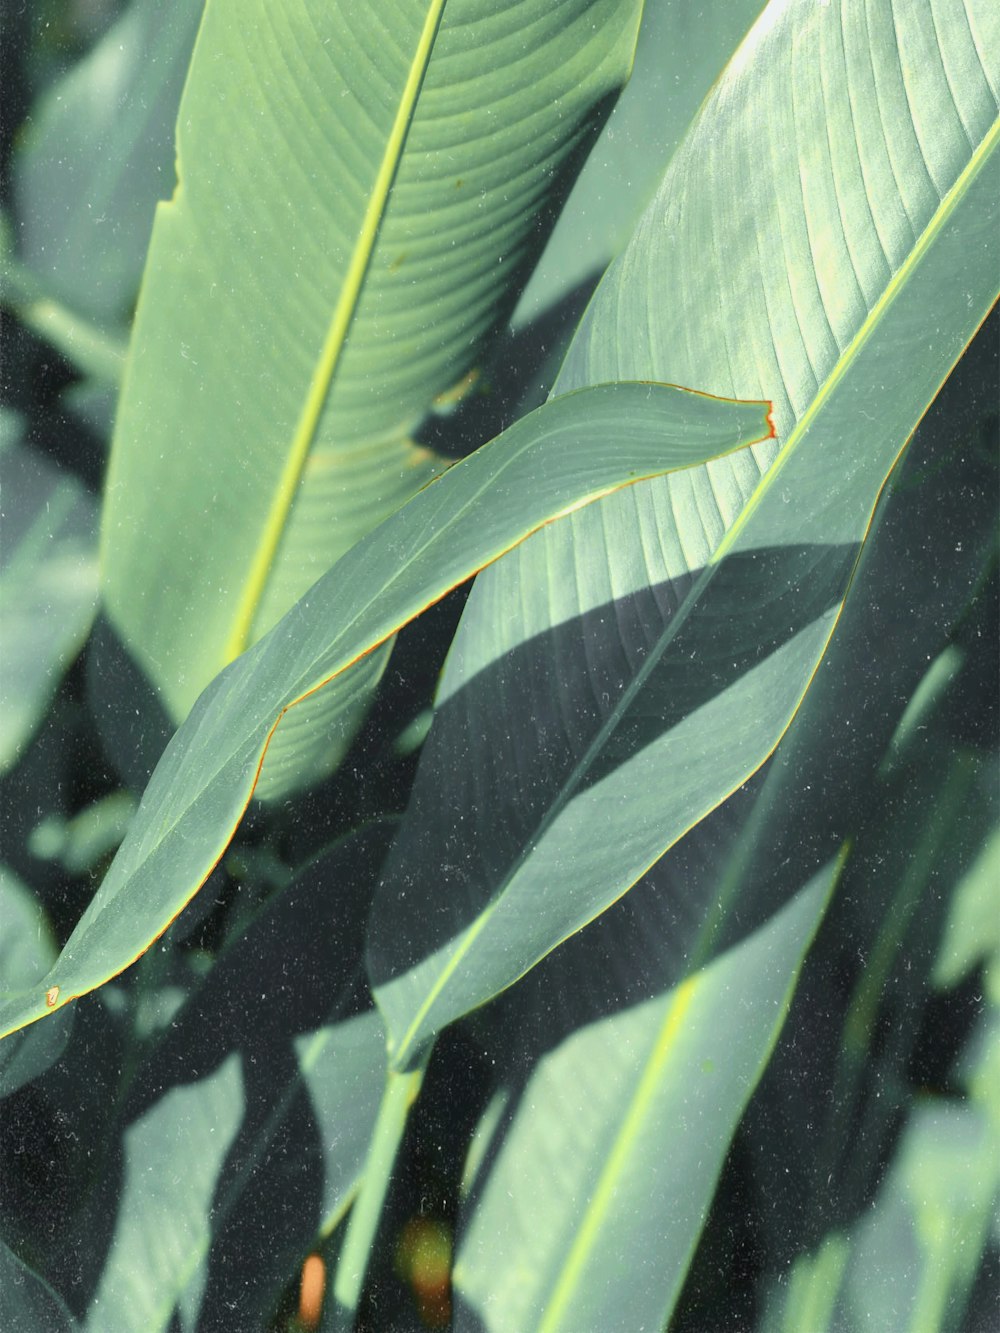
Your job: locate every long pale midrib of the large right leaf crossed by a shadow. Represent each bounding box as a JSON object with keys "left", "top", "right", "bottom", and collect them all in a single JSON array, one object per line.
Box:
[{"left": 389, "top": 109, "right": 1000, "bottom": 1065}]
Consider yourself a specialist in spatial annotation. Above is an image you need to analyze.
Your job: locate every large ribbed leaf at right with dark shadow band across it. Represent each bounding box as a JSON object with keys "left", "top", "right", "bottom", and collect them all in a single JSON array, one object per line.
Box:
[{"left": 369, "top": 0, "right": 1000, "bottom": 1064}]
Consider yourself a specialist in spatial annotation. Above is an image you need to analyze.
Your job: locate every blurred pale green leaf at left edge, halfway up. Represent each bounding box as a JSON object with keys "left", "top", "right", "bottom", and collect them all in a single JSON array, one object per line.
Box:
[{"left": 0, "top": 431, "right": 97, "bottom": 773}]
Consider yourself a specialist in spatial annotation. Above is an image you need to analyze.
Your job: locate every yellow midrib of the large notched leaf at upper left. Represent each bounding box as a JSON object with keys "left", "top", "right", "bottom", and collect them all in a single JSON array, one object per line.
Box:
[{"left": 223, "top": 0, "right": 448, "bottom": 663}]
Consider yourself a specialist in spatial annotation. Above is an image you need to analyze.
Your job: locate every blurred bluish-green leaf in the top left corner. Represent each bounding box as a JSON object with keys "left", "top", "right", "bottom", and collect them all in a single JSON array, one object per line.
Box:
[{"left": 13, "top": 0, "right": 203, "bottom": 326}]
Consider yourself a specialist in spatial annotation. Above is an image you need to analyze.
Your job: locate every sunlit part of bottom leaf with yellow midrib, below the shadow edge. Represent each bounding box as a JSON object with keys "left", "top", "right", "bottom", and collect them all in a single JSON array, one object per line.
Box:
[{"left": 455, "top": 865, "right": 839, "bottom": 1333}]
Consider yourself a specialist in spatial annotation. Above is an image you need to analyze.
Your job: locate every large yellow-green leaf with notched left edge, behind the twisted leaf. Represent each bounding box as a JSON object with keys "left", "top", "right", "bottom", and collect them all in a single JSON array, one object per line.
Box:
[{"left": 103, "top": 0, "right": 641, "bottom": 789}]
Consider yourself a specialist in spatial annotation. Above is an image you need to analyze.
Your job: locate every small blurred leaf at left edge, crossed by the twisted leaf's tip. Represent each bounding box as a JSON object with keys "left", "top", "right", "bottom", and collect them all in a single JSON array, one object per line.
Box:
[{"left": 0, "top": 865, "right": 72, "bottom": 1097}]
